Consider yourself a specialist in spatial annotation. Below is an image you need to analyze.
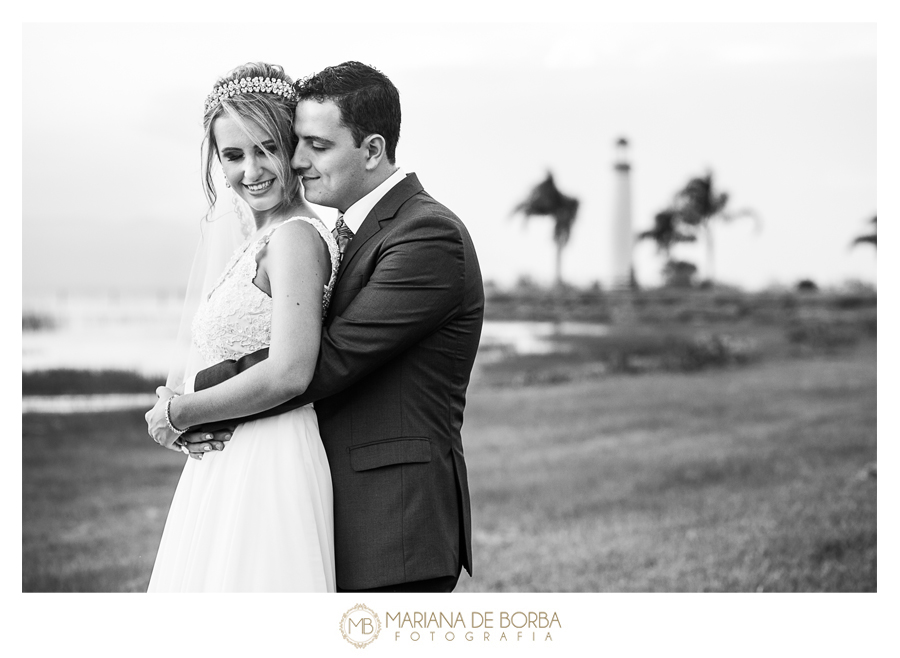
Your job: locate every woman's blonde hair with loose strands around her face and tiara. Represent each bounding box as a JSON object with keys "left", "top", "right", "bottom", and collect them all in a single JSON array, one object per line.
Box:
[{"left": 201, "top": 62, "right": 303, "bottom": 211}]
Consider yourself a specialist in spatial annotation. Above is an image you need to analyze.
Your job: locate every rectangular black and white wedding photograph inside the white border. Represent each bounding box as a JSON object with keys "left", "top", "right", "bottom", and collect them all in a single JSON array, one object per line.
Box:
[{"left": 15, "top": 9, "right": 890, "bottom": 655}]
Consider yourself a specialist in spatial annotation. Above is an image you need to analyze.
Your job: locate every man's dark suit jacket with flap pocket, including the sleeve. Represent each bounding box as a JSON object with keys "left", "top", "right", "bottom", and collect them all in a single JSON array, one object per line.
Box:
[{"left": 195, "top": 174, "right": 484, "bottom": 589}]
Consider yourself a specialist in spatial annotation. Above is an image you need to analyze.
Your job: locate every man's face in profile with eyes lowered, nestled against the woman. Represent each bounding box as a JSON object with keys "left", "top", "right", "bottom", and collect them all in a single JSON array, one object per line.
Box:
[{"left": 291, "top": 100, "right": 366, "bottom": 212}]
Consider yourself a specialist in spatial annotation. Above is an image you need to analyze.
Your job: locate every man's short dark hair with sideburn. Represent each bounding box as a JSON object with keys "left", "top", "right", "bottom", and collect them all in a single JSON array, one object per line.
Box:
[{"left": 294, "top": 62, "right": 400, "bottom": 164}]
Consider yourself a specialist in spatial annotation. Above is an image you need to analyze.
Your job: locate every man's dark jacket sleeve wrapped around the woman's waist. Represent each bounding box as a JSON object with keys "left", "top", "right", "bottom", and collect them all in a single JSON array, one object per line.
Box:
[{"left": 192, "top": 214, "right": 466, "bottom": 431}]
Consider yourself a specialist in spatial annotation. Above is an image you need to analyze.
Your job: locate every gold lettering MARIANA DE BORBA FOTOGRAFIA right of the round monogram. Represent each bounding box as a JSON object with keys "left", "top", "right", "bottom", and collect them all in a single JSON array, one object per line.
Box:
[{"left": 384, "top": 611, "right": 562, "bottom": 642}]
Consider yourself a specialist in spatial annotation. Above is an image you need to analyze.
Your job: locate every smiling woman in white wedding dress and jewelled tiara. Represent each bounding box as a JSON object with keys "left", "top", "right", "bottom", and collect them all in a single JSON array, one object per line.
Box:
[{"left": 147, "top": 63, "right": 340, "bottom": 592}]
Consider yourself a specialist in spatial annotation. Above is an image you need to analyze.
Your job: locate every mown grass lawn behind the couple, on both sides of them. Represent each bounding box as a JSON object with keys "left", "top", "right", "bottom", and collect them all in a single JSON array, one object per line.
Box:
[{"left": 22, "top": 341, "right": 877, "bottom": 592}]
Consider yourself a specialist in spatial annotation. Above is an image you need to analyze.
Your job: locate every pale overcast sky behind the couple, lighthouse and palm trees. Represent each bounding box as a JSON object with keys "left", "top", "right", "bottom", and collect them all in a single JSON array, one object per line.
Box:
[{"left": 23, "top": 24, "right": 876, "bottom": 294}]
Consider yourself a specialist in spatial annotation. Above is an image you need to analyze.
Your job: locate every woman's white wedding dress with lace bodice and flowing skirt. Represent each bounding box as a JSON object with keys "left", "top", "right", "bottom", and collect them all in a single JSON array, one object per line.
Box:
[{"left": 148, "top": 217, "right": 340, "bottom": 592}]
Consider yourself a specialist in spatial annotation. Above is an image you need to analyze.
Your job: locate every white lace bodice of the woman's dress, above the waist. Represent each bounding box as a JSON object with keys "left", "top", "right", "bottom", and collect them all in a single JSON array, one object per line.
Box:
[{"left": 191, "top": 217, "right": 340, "bottom": 365}]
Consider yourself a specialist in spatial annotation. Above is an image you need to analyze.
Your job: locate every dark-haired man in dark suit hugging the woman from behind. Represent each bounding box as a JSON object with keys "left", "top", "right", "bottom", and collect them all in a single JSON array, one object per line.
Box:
[{"left": 183, "top": 62, "right": 484, "bottom": 592}]
